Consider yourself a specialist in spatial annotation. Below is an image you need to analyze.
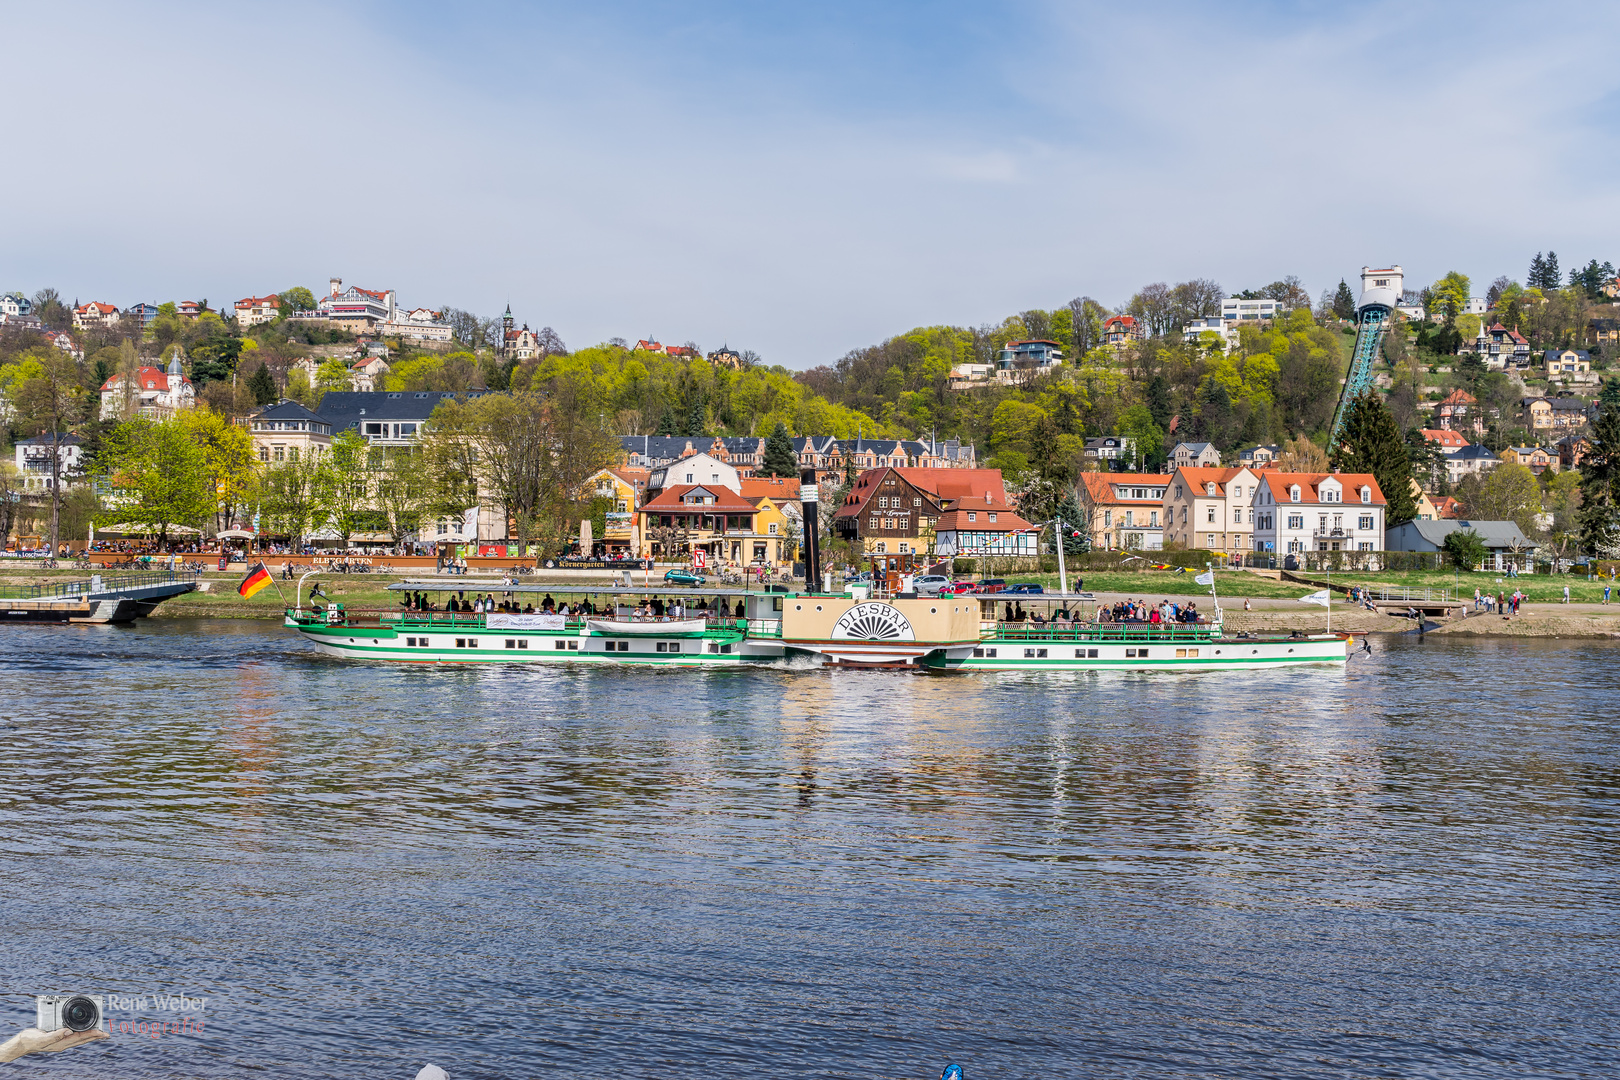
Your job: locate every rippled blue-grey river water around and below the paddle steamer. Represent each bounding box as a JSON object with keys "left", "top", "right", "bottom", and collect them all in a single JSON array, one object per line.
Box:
[{"left": 0, "top": 620, "right": 1620, "bottom": 1080}]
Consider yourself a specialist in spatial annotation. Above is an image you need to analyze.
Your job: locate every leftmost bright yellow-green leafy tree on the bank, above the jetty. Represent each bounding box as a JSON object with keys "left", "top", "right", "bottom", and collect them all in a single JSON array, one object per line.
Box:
[{"left": 97, "top": 416, "right": 215, "bottom": 544}]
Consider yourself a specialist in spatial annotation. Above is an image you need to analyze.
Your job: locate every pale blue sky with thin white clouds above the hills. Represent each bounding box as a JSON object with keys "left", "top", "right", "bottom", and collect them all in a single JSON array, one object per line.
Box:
[{"left": 0, "top": 0, "right": 1620, "bottom": 368}]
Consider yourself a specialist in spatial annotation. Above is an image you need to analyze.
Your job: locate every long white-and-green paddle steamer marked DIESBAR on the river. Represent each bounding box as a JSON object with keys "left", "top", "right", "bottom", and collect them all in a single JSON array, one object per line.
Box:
[{"left": 285, "top": 581, "right": 1349, "bottom": 672}]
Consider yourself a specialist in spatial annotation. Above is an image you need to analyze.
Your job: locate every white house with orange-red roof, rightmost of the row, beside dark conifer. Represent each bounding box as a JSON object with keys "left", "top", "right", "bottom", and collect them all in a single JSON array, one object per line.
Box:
[{"left": 1254, "top": 473, "right": 1388, "bottom": 552}]
